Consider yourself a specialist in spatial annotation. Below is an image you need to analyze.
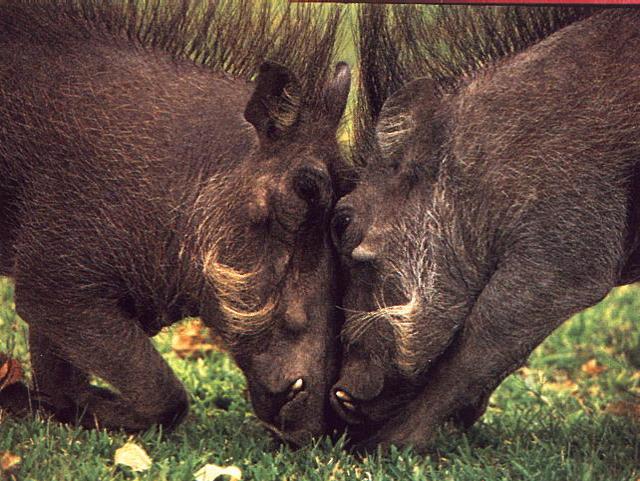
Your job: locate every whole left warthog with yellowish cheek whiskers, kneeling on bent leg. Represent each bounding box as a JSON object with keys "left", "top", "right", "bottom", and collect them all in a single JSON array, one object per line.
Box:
[{"left": 0, "top": 0, "right": 350, "bottom": 443}]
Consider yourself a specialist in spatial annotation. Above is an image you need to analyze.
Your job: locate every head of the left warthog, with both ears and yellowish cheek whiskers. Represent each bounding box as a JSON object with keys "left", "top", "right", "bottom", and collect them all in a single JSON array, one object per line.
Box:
[{"left": 196, "top": 62, "right": 350, "bottom": 444}]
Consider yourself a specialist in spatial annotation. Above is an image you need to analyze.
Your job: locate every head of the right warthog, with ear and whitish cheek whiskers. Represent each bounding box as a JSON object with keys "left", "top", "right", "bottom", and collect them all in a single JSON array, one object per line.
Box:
[{"left": 331, "top": 80, "right": 466, "bottom": 437}]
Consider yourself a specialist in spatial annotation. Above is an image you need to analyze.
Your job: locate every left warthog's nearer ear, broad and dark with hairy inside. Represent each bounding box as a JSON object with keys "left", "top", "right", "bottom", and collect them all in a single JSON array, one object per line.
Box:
[{"left": 244, "top": 61, "right": 302, "bottom": 140}]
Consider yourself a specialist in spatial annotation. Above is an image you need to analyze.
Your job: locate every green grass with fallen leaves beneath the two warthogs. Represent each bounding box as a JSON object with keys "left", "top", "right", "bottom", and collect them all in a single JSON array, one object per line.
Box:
[{"left": 0, "top": 279, "right": 640, "bottom": 481}]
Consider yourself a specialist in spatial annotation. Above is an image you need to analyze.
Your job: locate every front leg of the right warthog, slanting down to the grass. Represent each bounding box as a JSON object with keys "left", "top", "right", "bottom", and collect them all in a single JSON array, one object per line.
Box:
[{"left": 361, "top": 255, "right": 613, "bottom": 449}]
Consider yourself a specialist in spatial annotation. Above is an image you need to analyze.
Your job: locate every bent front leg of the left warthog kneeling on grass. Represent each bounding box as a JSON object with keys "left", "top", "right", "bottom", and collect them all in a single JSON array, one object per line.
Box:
[{"left": 16, "top": 298, "right": 188, "bottom": 431}]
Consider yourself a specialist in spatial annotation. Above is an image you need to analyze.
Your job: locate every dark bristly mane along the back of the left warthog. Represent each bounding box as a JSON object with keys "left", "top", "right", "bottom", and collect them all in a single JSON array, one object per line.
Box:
[{"left": 0, "top": 0, "right": 340, "bottom": 109}]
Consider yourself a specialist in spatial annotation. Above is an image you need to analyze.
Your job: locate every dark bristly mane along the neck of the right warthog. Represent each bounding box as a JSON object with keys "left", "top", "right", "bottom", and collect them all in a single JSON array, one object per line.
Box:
[{"left": 351, "top": 5, "right": 595, "bottom": 165}]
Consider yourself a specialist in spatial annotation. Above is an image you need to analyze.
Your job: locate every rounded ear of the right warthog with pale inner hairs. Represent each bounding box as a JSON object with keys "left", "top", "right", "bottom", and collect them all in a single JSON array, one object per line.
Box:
[{"left": 376, "top": 78, "right": 440, "bottom": 174}]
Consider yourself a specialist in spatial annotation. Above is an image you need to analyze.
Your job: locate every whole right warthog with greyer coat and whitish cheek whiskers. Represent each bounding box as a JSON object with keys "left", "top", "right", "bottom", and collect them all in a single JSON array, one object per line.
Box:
[{"left": 332, "top": 7, "right": 640, "bottom": 448}]
